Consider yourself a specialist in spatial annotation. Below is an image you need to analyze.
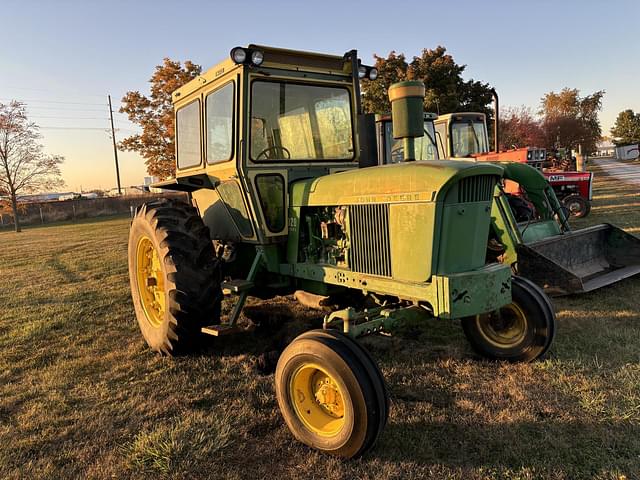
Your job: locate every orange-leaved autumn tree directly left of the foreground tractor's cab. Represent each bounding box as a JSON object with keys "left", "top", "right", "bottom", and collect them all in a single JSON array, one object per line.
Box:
[{"left": 119, "top": 58, "right": 202, "bottom": 179}]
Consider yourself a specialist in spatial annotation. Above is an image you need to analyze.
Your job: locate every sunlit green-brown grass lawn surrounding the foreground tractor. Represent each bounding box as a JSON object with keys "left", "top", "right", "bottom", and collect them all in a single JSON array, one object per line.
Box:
[{"left": 0, "top": 166, "right": 640, "bottom": 480}]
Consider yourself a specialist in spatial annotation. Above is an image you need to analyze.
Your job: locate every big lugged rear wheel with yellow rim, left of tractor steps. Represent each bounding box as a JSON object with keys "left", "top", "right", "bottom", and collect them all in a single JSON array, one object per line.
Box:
[{"left": 129, "top": 200, "right": 222, "bottom": 355}]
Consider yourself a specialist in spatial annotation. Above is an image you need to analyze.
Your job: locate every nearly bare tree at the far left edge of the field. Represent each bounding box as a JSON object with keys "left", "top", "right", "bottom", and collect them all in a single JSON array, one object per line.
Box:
[{"left": 0, "top": 101, "right": 64, "bottom": 232}]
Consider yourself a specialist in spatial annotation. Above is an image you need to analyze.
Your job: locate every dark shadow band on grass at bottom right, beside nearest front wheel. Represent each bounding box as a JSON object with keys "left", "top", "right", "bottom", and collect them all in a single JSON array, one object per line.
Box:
[{"left": 371, "top": 421, "right": 640, "bottom": 478}]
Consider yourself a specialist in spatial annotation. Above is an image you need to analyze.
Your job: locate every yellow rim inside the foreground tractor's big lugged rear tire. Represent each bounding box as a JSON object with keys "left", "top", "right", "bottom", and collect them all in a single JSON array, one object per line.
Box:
[{"left": 136, "top": 237, "right": 166, "bottom": 328}]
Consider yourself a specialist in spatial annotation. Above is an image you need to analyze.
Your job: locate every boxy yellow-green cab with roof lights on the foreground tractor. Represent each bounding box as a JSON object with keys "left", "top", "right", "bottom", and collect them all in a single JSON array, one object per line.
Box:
[{"left": 157, "top": 45, "right": 376, "bottom": 244}]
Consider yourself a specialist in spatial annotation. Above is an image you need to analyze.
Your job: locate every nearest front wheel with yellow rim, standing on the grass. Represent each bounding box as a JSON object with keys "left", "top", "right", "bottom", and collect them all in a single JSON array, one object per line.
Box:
[{"left": 275, "top": 331, "right": 386, "bottom": 458}]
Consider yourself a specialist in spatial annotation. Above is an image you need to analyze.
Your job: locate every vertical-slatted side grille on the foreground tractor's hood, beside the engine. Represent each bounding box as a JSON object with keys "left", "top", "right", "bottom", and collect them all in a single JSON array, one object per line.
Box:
[{"left": 349, "top": 203, "right": 391, "bottom": 277}]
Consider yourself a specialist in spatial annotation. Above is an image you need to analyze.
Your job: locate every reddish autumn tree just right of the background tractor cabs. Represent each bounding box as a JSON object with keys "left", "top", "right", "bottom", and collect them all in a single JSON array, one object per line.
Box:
[{"left": 500, "top": 106, "right": 545, "bottom": 150}]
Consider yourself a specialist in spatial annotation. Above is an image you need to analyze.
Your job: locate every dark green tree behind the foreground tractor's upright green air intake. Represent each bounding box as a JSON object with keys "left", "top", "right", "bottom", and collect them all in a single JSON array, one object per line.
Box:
[{"left": 362, "top": 46, "right": 493, "bottom": 118}]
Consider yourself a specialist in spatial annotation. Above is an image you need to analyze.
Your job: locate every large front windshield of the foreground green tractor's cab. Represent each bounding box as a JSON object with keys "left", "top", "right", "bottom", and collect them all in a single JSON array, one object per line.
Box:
[{"left": 250, "top": 80, "right": 354, "bottom": 161}]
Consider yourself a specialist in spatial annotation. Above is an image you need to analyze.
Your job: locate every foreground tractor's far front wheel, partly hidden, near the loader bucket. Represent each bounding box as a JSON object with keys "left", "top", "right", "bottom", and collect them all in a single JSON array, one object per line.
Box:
[{"left": 462, "top": 276, "right": 556, "bottom": 362}]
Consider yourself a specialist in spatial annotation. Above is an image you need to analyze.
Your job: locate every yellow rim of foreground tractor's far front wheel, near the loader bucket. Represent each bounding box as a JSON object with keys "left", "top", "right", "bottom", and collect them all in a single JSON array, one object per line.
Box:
[{"left": 476, "top": 303, "right": 527, "bottom": 348}]
